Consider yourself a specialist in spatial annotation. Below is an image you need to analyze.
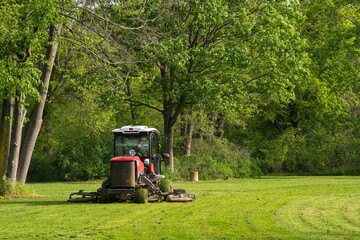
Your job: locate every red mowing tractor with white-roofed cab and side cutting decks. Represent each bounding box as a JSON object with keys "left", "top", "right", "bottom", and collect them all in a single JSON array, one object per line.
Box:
[{"left": 68, "top": 126, "right": 195, "bottom": 203}]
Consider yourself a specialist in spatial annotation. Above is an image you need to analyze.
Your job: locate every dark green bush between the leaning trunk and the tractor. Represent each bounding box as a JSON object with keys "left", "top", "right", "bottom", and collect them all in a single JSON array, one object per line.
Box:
[{"left": 28, "top": 133, "right": 113, "bottom": 182}]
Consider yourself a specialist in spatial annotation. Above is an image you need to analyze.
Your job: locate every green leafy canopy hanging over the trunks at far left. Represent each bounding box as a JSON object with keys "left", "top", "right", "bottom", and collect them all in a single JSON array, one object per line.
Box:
[{"left": 0, "top": 0, "right": 64, "bottom": 98}]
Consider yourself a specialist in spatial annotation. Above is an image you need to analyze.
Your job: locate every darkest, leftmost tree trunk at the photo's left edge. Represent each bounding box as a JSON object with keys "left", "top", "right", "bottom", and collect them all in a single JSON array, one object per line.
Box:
[{"left": 0, "top": 97, "right": 14, "bottom": 177}]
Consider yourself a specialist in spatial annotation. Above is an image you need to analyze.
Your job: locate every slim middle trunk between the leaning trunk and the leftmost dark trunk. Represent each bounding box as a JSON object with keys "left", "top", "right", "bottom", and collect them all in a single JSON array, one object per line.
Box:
[{"left": 9, "top": 94, "right": 26, "bottom": 183}]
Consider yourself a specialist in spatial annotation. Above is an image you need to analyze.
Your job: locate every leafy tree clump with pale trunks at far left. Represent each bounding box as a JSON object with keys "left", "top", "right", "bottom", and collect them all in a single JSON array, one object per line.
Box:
[{"left": 0, "top": 0, "right": 66, "bottom": 183}]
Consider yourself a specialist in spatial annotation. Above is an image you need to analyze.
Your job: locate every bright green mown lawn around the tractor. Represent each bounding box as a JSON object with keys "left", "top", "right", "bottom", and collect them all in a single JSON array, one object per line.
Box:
[{"left": 0, "top": 177, "right": 360, "bottom": 239}]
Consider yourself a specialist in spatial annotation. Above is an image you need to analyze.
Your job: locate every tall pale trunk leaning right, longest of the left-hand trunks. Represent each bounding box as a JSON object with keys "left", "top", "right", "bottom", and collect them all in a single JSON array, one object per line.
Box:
[{"left": 18, "top": 24, "right": 62, "bottom": 183}]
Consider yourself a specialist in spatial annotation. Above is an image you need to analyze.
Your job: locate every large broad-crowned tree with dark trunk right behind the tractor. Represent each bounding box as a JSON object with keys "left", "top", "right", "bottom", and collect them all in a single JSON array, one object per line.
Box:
[{"left": 130, "top": 0, "right": 302, "bottom": 169}]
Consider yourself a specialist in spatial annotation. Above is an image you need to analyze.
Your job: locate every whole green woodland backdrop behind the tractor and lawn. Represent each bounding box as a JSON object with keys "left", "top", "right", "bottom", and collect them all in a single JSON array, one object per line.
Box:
[{"left": 0, "top": 0, "right": 360, "bottom": 183}]
